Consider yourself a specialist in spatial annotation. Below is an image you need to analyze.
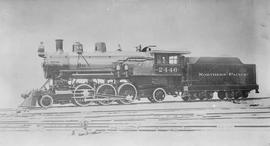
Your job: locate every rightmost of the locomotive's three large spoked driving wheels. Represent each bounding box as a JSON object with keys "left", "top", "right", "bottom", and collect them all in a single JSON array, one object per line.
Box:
[{"left": 116, "top": 83, "right": 138, "bottom": 104}]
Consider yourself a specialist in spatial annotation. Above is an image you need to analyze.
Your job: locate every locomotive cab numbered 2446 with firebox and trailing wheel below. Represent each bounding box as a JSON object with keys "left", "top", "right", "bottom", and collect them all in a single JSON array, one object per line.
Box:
[{"left": 130, "top": 50, "right": 190, "bottom": 99}]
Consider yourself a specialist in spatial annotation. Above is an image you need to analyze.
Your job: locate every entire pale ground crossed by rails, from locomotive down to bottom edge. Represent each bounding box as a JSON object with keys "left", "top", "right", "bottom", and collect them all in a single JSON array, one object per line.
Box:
[{"left": 0, "top": 98, "right": 270, "bottom": 146}]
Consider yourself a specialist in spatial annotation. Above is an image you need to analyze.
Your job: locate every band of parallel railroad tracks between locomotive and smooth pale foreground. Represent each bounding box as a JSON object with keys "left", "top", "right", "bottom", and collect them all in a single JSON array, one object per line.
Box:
[{"left": 0, "top": 99, "right": 270, "bottom": 132}]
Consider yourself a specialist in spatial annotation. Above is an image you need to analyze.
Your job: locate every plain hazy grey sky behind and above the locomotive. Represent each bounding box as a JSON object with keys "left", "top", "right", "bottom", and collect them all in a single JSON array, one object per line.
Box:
[{"left": 0, "top": 0, "right": 270, "bottom": 107}]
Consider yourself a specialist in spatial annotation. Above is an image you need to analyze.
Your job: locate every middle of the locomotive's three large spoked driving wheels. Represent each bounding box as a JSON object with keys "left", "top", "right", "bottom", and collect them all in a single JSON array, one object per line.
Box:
[{"left": 96, "top": 84, "right": 116, "bottom": 105}]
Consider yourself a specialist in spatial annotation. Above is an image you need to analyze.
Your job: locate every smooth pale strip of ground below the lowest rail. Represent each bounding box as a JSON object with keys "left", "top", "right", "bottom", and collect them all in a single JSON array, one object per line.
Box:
[{"left": 0, "top": 131, "right": 270, "bottom": 146}]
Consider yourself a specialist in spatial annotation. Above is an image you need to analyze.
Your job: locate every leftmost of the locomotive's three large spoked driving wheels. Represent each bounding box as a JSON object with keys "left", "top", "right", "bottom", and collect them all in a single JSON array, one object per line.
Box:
[{"left": 71, "top": 84, "right": 95, "bottom": 106}]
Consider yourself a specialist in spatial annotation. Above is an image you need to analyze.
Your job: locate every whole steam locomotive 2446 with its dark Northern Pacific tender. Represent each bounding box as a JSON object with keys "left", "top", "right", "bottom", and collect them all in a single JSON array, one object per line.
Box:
[{"left": 20, "top": 39, "right": 259, "bottom": 107}]
